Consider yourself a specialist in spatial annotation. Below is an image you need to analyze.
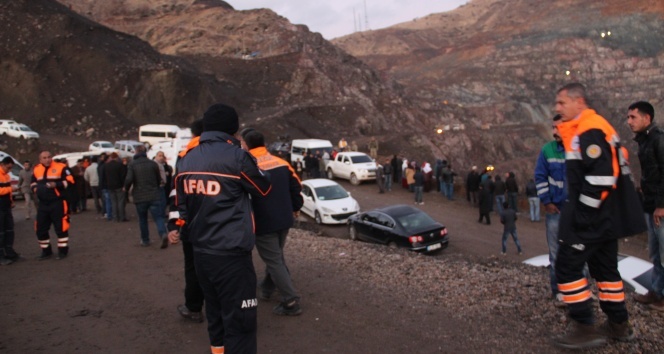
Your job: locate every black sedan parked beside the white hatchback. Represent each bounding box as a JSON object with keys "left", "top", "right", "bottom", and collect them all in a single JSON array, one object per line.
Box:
[{"left": 348, "top": 205, "right": 449, "bottom": 252}]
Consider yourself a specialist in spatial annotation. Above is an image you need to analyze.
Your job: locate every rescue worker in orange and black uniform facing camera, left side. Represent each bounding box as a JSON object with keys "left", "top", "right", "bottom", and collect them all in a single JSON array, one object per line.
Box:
[{"left": 30, "top": 151, "right": 74, "bottom": 261}]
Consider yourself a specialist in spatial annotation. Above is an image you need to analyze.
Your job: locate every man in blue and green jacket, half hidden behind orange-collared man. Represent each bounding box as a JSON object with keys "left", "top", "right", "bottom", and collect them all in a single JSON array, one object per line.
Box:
[{"left": 535, "top": 115, "right": 567, "bottom": 307}]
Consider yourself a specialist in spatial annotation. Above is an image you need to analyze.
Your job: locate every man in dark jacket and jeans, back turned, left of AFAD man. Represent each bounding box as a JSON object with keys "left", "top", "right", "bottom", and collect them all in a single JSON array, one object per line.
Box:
[{"left": 124, "top": 146, "right": 168, "bottom": 249}]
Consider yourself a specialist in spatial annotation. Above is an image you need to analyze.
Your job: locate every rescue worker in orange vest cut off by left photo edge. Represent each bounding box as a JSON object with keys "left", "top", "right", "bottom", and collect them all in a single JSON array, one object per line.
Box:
[{"left": 0, "top": 156, "right": 20, "bottom": 265}]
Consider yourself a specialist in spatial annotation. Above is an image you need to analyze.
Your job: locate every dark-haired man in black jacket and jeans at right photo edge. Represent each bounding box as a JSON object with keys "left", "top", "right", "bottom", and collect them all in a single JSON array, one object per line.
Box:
[{"left": 627, "top": 101, "right": 664, "bottom": 311}]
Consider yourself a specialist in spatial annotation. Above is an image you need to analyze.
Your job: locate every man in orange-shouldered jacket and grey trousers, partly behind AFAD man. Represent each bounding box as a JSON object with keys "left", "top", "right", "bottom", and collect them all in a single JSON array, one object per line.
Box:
[{"left": 242, "top": 130, "right": 303, "bottom": 316}]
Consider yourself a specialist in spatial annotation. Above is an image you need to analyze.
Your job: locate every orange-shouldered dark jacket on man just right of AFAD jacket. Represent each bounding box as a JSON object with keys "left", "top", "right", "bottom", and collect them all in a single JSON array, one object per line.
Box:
[{"left": 249, "top": 146, "right": 304, "bottom": 237}]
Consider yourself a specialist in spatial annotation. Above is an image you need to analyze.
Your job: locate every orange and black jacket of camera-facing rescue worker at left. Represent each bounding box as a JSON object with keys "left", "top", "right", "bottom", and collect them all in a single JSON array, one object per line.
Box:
[{"left": 30, "top": 161, "right": 74, "bottom": 203}]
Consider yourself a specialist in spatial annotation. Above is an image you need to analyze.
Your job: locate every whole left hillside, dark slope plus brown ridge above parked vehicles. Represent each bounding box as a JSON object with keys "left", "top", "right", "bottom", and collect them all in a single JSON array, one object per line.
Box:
[{"left": 5, "top": 0, "right": 436, "bottom": 163}]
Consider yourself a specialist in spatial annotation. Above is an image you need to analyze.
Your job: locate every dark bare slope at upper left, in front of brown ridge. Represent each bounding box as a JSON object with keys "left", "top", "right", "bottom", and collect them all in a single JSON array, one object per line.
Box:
[{"left": 0, "top": 0, "right": 223, "bottom": 138}]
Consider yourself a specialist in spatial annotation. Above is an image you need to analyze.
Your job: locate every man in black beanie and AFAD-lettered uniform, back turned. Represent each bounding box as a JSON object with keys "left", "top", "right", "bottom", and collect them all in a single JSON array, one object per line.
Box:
[{"left": 171, "top": 104, "right": 270, "bottom": 353}]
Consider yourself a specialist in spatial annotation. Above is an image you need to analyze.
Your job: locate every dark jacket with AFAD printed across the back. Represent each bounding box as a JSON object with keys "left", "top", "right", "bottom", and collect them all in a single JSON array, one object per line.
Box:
[{"left": 174, "top": 131, "right": 271, "bottom": 255}]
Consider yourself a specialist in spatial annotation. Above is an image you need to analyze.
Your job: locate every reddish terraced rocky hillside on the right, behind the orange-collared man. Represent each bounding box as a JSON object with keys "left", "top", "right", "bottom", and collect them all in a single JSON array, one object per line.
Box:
[{"left": 333, "top": 0, "right": 664, "bottom": 177}]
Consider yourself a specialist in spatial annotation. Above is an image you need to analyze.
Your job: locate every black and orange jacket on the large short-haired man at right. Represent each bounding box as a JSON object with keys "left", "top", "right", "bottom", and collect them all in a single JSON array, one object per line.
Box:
[{"left": 558, "top": 109, "right": 640, "bottom": 244}]
